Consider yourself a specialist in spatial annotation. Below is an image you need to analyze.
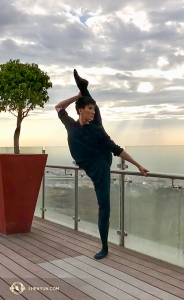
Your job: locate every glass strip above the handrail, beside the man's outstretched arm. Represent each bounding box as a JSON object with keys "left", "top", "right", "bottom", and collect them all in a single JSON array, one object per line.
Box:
[{"left": 125, "top": 146, "right": 184, "bottom": 174}]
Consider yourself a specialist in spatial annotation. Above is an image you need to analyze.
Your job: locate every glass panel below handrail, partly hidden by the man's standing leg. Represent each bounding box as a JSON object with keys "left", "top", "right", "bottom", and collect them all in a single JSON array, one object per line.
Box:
[{"left": 78, "top": 171, "right": 120, "bottom": 244}]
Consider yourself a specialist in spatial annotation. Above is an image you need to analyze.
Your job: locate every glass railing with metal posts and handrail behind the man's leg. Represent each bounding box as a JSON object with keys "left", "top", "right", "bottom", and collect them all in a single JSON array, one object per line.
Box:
[{"left": 37, "top": 165, "right": 184, "bottom": 267}]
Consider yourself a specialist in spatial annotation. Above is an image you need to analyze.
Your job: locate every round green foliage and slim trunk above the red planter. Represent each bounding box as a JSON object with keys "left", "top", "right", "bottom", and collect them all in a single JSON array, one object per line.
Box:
[{"left": 0, "top": 59, "right": 52, "bottom": 153}]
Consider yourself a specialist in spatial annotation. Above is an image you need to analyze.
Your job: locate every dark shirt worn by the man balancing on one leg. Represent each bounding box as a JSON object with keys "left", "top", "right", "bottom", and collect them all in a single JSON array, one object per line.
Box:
[{"left": 58, "top": 106, "right": 123, "bottom": 169}]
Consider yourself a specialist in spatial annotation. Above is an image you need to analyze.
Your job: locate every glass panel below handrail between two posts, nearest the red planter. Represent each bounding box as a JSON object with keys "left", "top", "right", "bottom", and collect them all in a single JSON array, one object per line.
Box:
[{"left": 45, "top": 168, "right": 75, "bottom": 228}]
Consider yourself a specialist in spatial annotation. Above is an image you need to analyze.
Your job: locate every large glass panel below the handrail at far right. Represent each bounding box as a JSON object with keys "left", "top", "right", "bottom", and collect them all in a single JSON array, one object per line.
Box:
[{"left": 125, "top": 176, "right": 184, "bottom": 267}]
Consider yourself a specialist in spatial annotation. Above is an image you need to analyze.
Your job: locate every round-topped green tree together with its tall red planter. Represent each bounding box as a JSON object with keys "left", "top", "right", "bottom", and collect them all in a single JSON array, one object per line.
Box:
[{"left": 0, "top": 60, "right": 52, "bottom": 235}]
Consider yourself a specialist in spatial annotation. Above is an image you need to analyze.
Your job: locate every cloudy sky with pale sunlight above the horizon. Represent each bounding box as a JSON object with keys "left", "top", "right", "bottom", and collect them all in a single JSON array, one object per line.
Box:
[{"left": 0, "top": 0, "right": 184, "bottom": 146}]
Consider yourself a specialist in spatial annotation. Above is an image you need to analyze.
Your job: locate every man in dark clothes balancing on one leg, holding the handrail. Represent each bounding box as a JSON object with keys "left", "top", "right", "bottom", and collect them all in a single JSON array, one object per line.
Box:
[{"left": 55, "top": 70, "right": 148, "bottom": 259}]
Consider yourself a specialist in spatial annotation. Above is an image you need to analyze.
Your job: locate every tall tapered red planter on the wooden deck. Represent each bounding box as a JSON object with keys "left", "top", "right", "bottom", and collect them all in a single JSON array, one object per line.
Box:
[{"left": 0, "top": 154, "right": 47, "bottom": 235}]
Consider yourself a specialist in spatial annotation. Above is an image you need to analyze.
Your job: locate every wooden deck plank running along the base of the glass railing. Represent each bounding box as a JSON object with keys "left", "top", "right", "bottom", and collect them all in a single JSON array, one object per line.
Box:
[{"left": 32, "top": 222, "right": 184, "bottom": 281}]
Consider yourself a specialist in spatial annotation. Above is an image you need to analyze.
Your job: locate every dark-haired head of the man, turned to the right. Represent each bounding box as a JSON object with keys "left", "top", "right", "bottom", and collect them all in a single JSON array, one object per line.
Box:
[{"left": 75, "top": 97, "right": 96, "bottom": 121}]
